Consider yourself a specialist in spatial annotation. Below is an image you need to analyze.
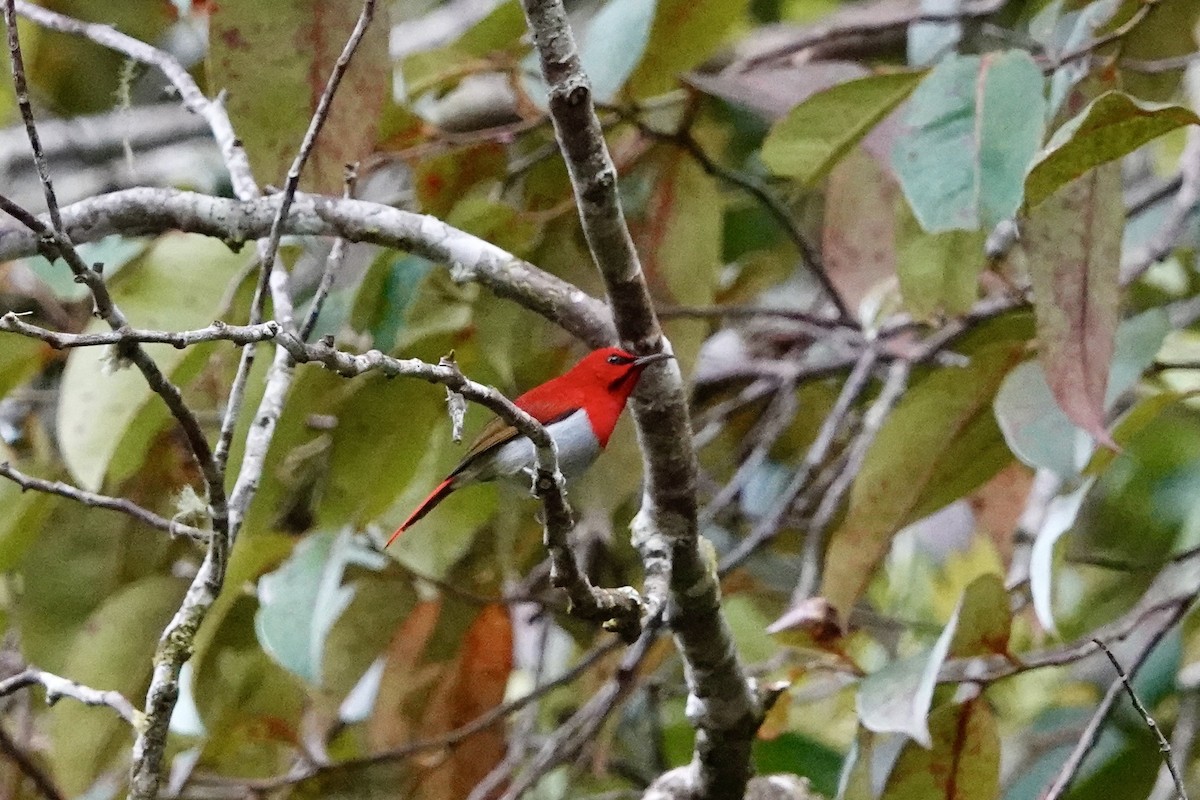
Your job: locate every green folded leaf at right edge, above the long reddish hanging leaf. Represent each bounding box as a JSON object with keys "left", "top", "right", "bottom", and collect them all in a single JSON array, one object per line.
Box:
[{"left": 1025, "top": 91, "right": 1200, "bottom": 209}]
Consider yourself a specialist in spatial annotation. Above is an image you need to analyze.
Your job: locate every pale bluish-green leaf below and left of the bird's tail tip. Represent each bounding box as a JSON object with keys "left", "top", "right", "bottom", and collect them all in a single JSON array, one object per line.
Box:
[{"left": 254, "top": 530, "right": 386, "bottom": 686}]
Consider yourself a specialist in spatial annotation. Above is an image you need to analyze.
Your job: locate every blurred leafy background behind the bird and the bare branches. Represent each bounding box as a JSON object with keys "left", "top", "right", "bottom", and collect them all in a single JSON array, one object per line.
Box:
[{"left": 0, "top": 0, "right": 1200, "bottom": 800}]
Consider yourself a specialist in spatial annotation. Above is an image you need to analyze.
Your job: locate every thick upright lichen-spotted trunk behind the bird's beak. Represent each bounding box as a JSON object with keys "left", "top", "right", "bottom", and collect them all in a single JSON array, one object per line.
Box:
[{"left": 522, "top": 0, "right": 762, "bottom": 798}]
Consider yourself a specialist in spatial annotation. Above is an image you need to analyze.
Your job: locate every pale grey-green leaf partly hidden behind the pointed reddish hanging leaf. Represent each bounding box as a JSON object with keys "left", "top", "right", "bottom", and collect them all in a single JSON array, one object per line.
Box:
[{"left": 994, "top": 308, "right": 1170, "bottom": 480}]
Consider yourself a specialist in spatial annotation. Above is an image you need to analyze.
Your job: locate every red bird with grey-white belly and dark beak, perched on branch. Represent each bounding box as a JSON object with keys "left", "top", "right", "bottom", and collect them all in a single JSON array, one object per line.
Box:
[{"left": 388, "top": 347, "right": 672, "bottom": 545}]
